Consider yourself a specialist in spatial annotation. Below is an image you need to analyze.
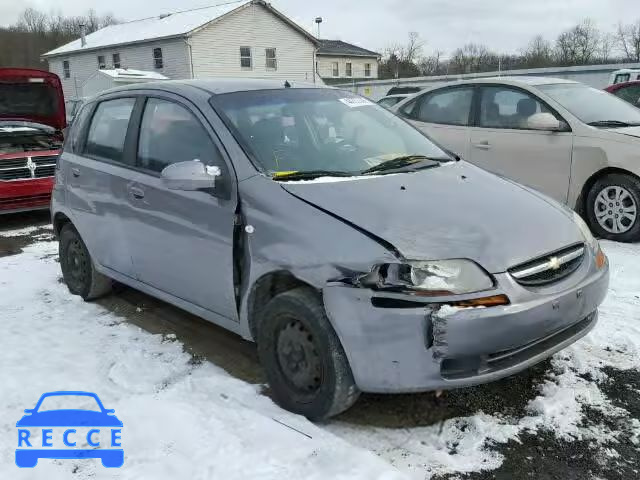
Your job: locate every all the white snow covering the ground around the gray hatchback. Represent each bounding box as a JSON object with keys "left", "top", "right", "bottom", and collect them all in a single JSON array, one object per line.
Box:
[{"left": 0, "top": 225, "right": 640, "bottom": 480}]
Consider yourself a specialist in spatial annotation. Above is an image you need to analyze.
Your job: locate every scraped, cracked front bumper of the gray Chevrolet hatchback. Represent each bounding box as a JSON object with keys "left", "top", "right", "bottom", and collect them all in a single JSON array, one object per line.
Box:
[{"left": 323, "top": 255, "right": 609, "bottom": 393}]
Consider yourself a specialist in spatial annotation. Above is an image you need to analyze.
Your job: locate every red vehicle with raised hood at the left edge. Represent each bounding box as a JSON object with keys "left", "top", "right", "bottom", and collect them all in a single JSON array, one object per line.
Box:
[{"left": 0, "top": 68, "right": 66, "bottom": 214}]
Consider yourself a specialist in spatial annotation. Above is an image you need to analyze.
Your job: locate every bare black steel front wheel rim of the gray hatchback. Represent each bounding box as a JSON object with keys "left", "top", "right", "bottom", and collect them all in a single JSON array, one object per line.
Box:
[{"left": 278, "top": 320, "right": 322, "bottom": 394}]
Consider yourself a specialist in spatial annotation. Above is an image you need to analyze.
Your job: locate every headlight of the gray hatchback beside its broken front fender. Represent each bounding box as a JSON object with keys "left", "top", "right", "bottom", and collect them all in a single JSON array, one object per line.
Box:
[{"left": 361, "top": 259, "right": 494, "bottom": 296}]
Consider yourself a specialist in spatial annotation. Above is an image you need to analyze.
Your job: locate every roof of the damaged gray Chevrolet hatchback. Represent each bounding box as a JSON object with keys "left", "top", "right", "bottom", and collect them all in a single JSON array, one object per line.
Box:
[{"left": 104, "top": 78, "right": 330, "bottom": 95}]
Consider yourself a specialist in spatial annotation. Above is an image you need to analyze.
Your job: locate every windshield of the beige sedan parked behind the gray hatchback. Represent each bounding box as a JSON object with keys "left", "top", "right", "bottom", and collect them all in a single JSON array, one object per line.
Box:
[{"left": 538, "top": 83, "right": 640, "bottom": 125}]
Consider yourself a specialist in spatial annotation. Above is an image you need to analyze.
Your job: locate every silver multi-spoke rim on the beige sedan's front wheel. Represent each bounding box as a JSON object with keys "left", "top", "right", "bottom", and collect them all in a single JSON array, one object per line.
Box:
[{"left": 594, "top": 186, "right": 638, "bottom": 234}]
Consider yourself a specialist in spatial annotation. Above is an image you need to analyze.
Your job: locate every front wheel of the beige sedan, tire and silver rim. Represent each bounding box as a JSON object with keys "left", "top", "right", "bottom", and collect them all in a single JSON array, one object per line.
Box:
[{"left": 586, "top": 173, "right": 640, "bottom": 242}]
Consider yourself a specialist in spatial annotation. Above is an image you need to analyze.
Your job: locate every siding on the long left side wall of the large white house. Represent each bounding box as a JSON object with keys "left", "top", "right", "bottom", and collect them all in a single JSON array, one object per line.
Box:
[{"left": 48, "top": 38, "right": 191, "bottom": 98}]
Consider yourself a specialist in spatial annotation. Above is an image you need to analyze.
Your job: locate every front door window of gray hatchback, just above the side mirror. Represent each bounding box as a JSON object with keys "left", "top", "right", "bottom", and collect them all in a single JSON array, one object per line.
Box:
[{"left": 138, "top": 98, "right": 225, "bottom": 173}]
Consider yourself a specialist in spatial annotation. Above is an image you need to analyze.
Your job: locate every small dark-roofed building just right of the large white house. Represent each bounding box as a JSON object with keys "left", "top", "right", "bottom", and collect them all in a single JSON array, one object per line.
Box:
[{"left": 316, "top": 40, "right": 380, "bottom": 83}]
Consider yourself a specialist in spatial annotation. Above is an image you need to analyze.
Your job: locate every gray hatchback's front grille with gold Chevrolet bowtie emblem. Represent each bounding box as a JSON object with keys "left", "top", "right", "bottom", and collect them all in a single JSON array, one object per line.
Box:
[{"left": 509, "top": 244, "right": 585, "bottom": 287}]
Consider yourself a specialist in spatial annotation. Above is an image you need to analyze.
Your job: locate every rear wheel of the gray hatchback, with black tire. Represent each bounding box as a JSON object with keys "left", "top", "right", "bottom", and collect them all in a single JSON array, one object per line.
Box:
[{"left": 58, "top": 224, "right": 112, "bottom": 301}]
